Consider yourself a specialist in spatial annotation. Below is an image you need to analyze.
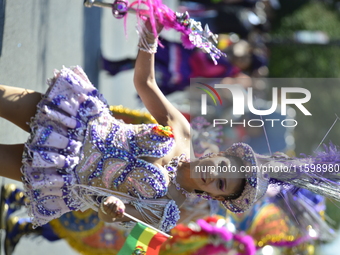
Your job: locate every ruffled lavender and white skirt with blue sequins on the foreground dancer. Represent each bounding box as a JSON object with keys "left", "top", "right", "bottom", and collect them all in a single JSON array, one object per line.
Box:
[{"left": 22, "top": 67, "right": 109, "bottom": 226}]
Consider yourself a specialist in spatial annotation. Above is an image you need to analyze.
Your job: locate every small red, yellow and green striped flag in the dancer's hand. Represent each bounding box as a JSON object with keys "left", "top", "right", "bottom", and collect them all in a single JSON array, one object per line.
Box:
[{"left": 117, "top": 222, "right": 167, "bottom": 255}]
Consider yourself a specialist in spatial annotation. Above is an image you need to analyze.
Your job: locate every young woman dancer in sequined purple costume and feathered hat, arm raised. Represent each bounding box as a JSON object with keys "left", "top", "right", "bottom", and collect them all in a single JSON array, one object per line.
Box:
[{"left": 0, "top": 0, "right": 339, "bottom": 235}]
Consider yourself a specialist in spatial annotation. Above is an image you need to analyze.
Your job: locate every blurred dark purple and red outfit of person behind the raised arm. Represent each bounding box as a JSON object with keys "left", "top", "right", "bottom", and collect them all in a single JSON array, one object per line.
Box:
[{"left": 100, "top": 36, "right": 240, "bottom": 95}]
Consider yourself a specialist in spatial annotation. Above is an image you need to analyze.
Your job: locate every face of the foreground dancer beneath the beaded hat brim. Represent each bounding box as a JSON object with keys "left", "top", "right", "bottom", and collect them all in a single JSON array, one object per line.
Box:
[{"left": 193, "top": 156, "right": 245, "bottom": 201}]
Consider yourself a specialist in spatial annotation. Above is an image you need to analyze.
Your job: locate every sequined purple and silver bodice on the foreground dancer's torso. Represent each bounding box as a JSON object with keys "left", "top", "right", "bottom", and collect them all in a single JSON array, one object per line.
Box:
[{"left": 78, "top": 119, "right": 173, "bottom": 199}]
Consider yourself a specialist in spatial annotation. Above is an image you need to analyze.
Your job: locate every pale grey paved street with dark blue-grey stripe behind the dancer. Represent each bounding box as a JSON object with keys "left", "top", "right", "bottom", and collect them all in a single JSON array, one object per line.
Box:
[{"left": 0, "top": 0, "right": 137, "bottom": 255}]
